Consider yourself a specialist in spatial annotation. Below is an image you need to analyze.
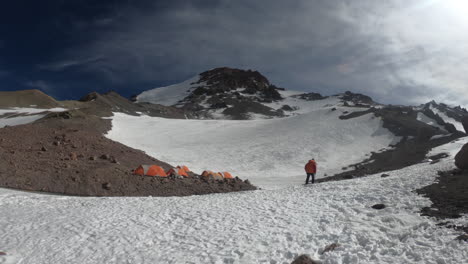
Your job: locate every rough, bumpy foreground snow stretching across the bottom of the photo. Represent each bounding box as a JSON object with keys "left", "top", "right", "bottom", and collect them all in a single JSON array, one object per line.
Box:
[{"left": 0, "top": 138, "right": 468, "bottom": 264}]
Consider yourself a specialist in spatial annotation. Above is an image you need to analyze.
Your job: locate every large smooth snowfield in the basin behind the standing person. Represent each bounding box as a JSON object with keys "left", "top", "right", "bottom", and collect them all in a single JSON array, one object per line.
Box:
[{"left": 106, "top": 98, "right": 400, "bottom": 188}]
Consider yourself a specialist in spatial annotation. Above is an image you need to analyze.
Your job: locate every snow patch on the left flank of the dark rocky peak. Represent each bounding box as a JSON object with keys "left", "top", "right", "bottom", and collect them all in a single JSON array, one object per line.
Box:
[{"left": 136, "top": 75, "right": 203, "bottom": 106}]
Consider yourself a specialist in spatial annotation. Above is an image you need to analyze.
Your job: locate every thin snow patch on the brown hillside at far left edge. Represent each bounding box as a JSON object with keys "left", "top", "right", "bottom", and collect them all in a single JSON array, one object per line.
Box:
[{"left": 0, "top": 107, "right": 67, "bottom": 128}]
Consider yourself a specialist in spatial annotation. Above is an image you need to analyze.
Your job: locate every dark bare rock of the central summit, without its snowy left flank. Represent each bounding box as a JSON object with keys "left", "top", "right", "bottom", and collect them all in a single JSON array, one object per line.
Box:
[{"left": 177, "top": 67, "right": 284, "bottom": 119}]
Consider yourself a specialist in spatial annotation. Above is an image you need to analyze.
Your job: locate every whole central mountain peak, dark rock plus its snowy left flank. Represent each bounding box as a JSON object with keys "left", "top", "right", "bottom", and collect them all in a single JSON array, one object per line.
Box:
[{"left": 136, "top": 67, "right": 283, "bottom": 119}]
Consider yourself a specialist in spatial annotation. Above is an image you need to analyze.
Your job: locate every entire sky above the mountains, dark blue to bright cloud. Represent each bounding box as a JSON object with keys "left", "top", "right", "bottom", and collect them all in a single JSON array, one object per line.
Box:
[{"left": 0, "top": 0, "right": 468, "bottom": 107}]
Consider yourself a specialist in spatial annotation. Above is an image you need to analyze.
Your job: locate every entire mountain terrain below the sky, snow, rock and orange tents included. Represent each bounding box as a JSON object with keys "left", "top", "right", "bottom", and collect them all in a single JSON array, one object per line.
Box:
[{"left": 0, "top": 68, "right": 468, "bottom": 263}]
